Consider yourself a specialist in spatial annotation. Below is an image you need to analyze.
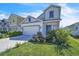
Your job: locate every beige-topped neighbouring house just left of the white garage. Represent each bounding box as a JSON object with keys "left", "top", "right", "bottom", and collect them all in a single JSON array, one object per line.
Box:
[{"left": 8, "top": 14, "right": 24, "bottom": 31}]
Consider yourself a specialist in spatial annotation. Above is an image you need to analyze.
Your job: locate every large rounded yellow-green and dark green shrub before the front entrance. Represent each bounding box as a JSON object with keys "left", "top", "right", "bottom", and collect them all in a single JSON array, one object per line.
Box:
[{"left": 46, "top": 29, "right": 70, "bottom": 45}]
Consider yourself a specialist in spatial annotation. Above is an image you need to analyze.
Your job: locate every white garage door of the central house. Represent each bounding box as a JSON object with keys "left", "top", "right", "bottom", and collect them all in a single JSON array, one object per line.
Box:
[{"left": 23, "top": 26, "right": 39, "bottom": 35}]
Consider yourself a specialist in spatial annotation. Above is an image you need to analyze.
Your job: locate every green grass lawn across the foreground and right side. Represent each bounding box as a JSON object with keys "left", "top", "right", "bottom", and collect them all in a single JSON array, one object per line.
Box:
[{"left": 0, "top": 38, "right": 79, "bottom": 56}]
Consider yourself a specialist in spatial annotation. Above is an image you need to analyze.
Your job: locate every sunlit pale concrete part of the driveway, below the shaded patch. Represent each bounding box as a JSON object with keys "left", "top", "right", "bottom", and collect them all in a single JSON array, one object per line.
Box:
[{"left": 0, "top": 38, "right": 27, "bottom": 52}]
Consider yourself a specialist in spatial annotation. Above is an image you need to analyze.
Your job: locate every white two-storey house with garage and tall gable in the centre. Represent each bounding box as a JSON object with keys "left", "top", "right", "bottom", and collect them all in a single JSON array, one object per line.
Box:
[{"left": 21, "top": 5, "right": 61, "bottom": 36}]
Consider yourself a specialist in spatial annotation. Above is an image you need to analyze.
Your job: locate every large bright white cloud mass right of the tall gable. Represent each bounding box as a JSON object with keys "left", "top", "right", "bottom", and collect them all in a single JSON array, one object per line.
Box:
[{"left": 58, "top": 4, "right": 79, "bottom": 27}]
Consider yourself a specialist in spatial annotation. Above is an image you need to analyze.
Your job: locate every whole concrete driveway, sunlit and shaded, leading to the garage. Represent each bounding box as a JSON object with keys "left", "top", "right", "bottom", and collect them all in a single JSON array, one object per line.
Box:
[{"left": 0, "top": 35, "right": 31, "bottom": 52}]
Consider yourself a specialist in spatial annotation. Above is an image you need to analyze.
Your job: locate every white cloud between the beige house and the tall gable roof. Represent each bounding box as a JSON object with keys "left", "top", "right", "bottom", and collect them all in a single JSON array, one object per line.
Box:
[{"left": 18, "top": 10, "right": 42, "bottom": 17}]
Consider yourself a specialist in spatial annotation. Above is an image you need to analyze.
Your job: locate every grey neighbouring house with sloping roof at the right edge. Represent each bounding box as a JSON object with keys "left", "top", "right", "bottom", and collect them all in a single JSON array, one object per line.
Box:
[{"left": 65, "top": 22, "right": 79, "bottom": 36}]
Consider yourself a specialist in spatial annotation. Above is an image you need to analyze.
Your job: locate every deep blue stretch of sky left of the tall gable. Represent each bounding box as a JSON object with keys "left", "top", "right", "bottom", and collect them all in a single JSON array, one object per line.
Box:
[{"left": 0, "top": 3, "right": 48, "bottom": 14}]
